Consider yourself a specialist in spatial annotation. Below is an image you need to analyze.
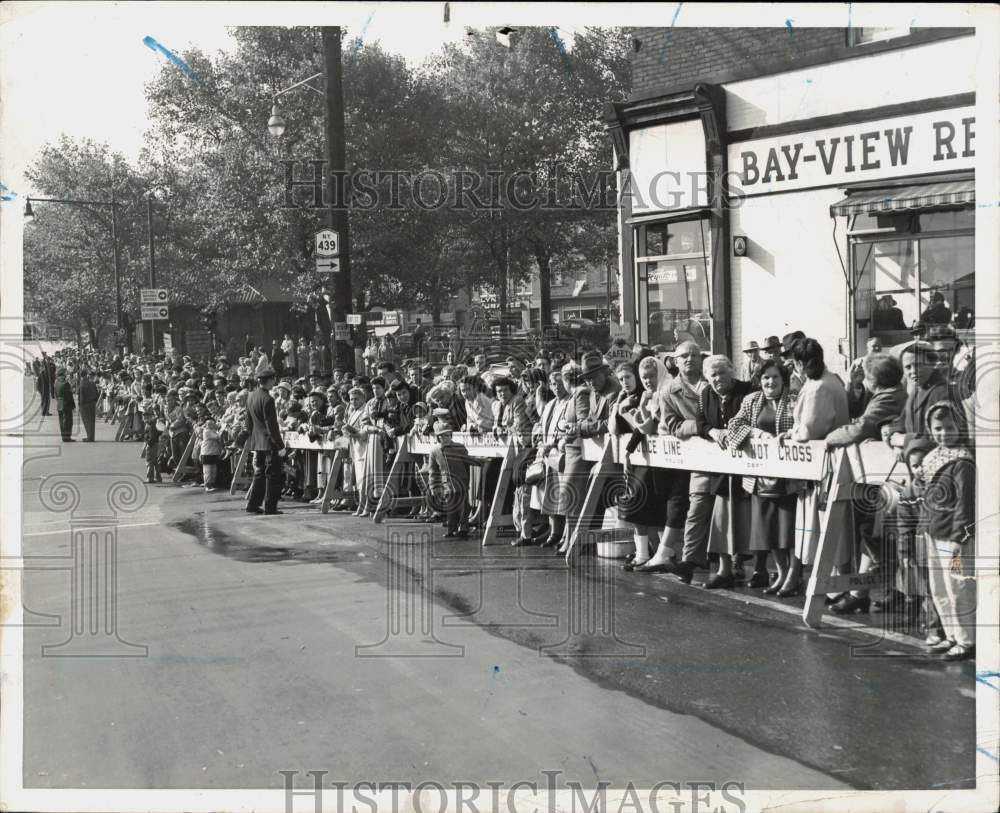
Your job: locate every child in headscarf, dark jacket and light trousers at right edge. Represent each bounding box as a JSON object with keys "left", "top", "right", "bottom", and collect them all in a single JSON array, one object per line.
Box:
[{"left": 909, "top": 401, "right": 976, "bottom": 660}]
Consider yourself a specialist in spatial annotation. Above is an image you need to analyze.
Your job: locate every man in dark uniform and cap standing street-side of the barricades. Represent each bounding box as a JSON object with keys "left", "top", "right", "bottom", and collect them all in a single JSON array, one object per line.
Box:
[{"left": 240, "top": 366, "right": 285, "bottom": 514}]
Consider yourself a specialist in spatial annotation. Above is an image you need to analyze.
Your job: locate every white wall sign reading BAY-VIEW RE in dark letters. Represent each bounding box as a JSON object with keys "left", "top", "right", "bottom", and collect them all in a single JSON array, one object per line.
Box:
[{"left": 729, "top": 107, "right": 976, "bottom": 195}]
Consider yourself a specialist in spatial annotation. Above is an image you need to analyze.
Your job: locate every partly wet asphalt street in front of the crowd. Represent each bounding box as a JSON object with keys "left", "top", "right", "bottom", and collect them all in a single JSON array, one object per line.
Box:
[{"left": 17, "top": 406, "right": 975, "bottom": 789}]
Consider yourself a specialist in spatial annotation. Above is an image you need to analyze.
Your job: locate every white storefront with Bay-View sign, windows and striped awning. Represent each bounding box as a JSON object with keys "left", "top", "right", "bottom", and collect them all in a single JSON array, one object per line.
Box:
[{"left": 606, "top": 29, "right": 976, "bottom": 370}]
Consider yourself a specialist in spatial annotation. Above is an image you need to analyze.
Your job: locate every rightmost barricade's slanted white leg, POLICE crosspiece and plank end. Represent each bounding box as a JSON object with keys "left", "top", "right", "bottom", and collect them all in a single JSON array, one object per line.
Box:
[{"left": 800, "top": 441, "right": 907, "bottom": 628}]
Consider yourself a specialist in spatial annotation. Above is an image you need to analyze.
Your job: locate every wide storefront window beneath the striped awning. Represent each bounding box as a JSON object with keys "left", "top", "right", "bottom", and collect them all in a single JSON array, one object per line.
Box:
[{"left": 851, "top": 205, "right": 975, "bottom": 348}]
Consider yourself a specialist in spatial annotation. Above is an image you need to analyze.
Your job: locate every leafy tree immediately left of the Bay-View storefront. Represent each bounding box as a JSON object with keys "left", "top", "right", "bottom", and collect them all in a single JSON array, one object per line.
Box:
[{"left": 430, "top": 28, "right": 628, "bottom": 325}]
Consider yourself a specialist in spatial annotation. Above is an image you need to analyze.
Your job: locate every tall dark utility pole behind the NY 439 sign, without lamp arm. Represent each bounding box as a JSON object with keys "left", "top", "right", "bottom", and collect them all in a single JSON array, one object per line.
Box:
[{"left": 322, "top": 26, "right": 354, "bottom": 372}]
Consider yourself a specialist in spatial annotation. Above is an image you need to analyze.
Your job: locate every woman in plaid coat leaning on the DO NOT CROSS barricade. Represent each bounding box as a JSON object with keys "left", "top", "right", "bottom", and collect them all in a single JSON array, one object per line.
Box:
[{"left": 727, "top": 359, "right": 800, "bottom": 597}]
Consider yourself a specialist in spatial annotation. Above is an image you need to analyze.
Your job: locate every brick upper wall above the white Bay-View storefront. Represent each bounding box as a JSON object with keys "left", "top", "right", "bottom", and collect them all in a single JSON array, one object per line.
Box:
[{"left": 630, "top": 27, "right": 972, "bottom": 99}]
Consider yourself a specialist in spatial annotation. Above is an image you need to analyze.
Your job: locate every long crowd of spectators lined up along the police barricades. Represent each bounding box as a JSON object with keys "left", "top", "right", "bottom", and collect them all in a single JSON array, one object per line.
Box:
[{"left": 32, "top": 320, "right": 975, "bottom": 660}]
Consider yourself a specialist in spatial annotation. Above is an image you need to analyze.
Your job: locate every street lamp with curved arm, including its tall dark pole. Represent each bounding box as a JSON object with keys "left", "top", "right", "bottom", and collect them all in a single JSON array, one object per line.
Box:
[{"left": 267, "top": 26, "right": 354, "bottom": 371}]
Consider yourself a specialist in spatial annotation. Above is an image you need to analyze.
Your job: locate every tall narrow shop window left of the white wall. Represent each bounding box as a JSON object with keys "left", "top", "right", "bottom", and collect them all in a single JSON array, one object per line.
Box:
[{"left": 636, "top": 220, "right": 712, "bottom": 350}]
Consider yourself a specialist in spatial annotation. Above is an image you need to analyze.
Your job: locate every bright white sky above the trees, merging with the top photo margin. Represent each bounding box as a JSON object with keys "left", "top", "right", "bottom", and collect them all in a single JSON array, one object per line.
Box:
[{"left": 0, "top": 0, "right": 984, "bottom": 199}]
